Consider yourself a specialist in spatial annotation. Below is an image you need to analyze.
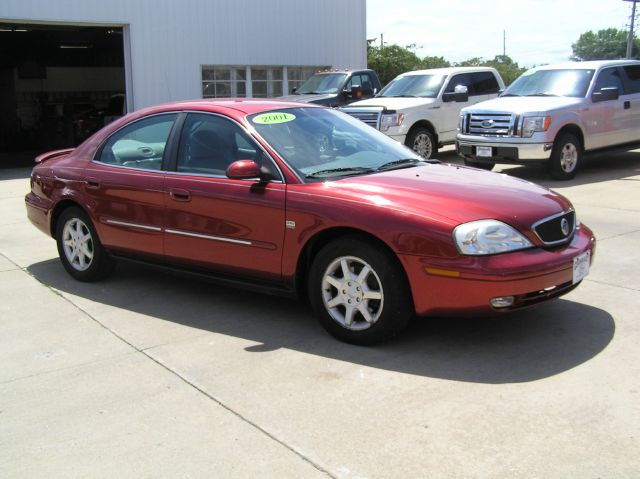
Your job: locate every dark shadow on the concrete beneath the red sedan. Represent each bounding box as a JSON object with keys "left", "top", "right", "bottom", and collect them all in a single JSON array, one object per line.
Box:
[{"left": 27, "top": 259, "right": 615, "bottom": 384}]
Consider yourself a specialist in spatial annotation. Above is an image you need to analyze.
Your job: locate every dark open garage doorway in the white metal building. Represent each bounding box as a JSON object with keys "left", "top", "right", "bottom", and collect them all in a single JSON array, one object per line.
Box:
[{"left": 0, "top": 22, "right": 126, "bottom": 167}]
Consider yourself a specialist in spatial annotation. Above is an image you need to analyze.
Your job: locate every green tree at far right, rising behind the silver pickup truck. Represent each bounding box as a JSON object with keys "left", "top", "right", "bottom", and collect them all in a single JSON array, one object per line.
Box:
[{"left": 571, "top": 28, "right": 640, "bottom": 61}]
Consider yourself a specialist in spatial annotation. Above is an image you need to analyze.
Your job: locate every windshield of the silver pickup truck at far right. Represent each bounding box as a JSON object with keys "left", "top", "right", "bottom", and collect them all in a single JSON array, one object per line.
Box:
[{"left": 501, "top": 69, "right": 594, "bottom": 98}]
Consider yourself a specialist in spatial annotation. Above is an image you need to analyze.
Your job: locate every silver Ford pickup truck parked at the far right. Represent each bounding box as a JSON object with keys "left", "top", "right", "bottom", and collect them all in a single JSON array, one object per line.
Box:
[{"left": 456, "top": 60, "right": 640, "bottom": 180}]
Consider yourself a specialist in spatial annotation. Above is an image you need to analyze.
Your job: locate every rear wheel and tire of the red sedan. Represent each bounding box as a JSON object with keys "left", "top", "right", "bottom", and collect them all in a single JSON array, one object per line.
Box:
[{"left": 56, "top": 207, "right": 115, "bottom": 282}]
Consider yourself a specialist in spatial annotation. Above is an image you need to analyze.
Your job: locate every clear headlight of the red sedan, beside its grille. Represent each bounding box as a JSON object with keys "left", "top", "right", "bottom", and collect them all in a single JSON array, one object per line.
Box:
[{"left": 453, "top": 220, "right": 533, "bottom": 256}]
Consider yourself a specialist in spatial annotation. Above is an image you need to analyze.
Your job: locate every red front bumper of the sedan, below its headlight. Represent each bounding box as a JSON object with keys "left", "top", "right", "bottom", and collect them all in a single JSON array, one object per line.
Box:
[{"left": 400, "top": 225, "right": 596, "bottom": 316}]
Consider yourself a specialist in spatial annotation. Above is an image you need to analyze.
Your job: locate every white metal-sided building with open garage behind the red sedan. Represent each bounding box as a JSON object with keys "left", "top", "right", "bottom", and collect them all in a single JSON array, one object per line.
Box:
[{"left": 0, "top": 0, "right": 366, "bottom": 152}]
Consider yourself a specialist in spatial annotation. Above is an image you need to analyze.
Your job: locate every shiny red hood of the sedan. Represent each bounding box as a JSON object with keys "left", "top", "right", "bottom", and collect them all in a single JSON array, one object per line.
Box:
[{"left": 316, "top": 164, "right": 571, "bottom": 228}]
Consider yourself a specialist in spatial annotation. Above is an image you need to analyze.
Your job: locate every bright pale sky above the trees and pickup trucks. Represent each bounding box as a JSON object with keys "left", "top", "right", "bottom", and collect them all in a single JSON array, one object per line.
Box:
[{"left": 366, "top": 0, "right": 640, "bottom": 67}]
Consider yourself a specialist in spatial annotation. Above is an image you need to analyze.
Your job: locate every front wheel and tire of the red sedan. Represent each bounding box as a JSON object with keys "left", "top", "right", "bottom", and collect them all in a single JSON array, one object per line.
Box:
[{"left": 308, "top": 237, "right": 414, "bottom": 345}]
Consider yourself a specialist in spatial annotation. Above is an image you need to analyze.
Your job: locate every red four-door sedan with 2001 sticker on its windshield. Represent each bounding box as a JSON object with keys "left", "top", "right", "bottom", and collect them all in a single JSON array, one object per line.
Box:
[{"left": 26, "top": 100, "right": 595, "bottom": 344}]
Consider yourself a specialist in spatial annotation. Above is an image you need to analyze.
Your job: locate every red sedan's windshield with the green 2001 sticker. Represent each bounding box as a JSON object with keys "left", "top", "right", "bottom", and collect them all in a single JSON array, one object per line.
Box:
[{"left": 248, "top": 107, "right": 423, "bottom": 182}]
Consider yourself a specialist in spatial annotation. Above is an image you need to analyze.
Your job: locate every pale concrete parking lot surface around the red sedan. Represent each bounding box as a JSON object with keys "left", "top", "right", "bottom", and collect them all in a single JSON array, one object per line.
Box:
[{"left": 0, "top": 149, "right": 640, "bottom": 478}]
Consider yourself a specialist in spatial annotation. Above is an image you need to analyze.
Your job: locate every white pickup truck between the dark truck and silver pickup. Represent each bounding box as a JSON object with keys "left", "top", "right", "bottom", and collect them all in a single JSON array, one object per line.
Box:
[{"left": 342, "top": 67, "right": 504, "bottom": 158}]
